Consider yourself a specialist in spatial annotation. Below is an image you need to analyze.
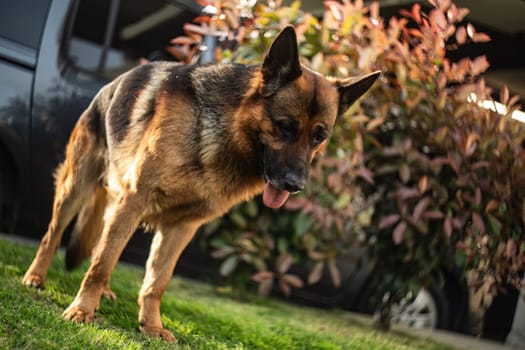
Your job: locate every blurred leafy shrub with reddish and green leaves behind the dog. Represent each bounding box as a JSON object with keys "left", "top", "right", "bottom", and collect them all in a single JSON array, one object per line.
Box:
[{"left": 177, "top": 0, "right": 525, "bottom": 322}]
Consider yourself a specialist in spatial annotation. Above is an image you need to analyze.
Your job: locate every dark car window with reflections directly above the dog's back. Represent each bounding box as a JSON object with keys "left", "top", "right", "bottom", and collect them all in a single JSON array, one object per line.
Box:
[{"left": 67, "top": 0, "right": 196, "bottom": 79}]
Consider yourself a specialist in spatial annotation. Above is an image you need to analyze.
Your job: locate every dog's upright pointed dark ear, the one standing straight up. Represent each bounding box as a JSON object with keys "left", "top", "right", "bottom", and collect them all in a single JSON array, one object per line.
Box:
[{"left": 261, "top": 26, "right": 301, "bottom": 97}]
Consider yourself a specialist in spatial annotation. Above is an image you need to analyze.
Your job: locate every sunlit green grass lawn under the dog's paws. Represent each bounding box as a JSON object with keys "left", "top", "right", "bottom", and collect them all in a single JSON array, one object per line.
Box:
[{"left": 0, "top": 238, "right": 451, "bottom": 350}]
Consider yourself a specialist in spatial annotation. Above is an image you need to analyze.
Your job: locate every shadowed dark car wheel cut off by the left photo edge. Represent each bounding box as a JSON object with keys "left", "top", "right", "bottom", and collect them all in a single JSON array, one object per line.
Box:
[{"left": 0, "top": 151, "right": 18, "bottom": 233}]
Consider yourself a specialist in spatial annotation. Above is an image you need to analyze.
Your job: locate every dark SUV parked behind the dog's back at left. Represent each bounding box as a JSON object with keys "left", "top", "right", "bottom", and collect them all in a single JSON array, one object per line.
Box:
[{"left": 0, "top": 0, "right": 200, "bottom": 238}]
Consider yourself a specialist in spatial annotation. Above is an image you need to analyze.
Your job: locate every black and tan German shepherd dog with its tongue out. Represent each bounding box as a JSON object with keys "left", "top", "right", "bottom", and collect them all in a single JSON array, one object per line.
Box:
[{"left": 23, "top": 27, "right": 380, "bottom": 341}]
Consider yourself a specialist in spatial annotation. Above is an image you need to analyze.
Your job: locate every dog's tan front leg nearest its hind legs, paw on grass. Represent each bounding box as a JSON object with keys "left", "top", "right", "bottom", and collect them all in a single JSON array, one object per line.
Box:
[{"left": 63, "top": 194, "right": 141, "bottom": 322}]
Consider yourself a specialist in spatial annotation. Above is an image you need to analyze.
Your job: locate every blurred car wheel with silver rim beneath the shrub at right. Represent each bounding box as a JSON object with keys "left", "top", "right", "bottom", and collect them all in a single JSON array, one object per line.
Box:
[{"left": 392, "top": 282, "right": 449, "bottom": 329}]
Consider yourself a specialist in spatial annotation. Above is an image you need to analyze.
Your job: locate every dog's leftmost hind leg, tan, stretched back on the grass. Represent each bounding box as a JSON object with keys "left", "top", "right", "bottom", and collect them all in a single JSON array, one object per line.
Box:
[{"left": 23, "top": 110, "right": 103, "bottom": 287}]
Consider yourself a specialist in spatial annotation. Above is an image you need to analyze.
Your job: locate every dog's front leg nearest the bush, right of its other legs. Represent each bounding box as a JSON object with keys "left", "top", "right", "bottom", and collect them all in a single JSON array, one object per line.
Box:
[{"left": 138, "top": 222, "right": 199, "bottom": 342}]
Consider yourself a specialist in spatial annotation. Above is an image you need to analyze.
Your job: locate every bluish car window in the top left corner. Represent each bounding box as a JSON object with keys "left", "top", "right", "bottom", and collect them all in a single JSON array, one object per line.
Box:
[{"left": 0, "top": 0, "right": 51, "bottom": 49}]
